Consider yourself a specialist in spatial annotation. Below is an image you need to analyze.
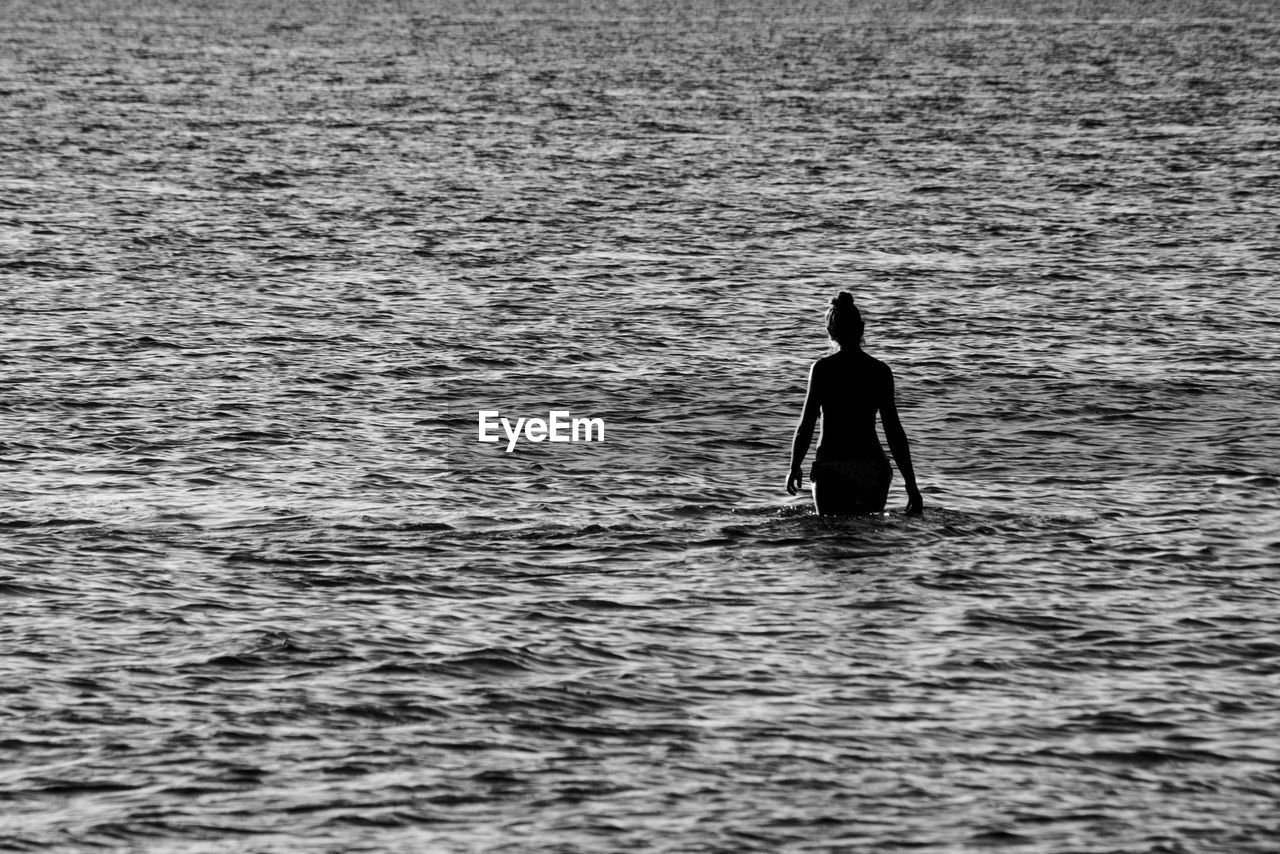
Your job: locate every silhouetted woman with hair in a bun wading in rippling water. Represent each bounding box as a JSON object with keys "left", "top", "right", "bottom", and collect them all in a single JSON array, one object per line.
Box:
[{"left": 787, "top": 291, "right": 924, "bottom": 516}]
